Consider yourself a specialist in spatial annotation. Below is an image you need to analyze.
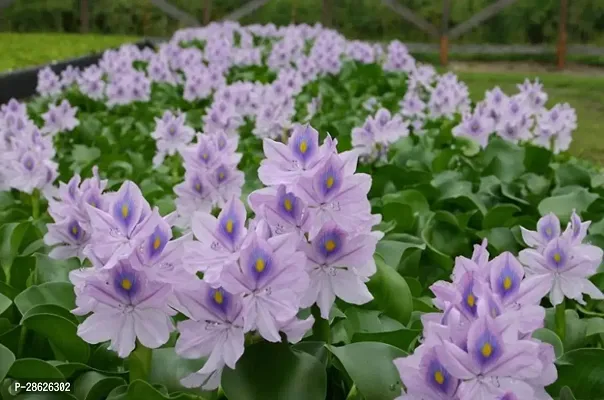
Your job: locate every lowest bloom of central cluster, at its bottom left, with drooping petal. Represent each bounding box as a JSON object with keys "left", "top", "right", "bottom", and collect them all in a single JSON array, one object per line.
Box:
[{"left": 175, "top": 281, "right": 245, "bottom": 390}]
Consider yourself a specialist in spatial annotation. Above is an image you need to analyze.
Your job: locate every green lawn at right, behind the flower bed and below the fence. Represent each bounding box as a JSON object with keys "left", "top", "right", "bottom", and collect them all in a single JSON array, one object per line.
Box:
[{"left": 457, "top": 71, "right": 604, "bottom": 165}]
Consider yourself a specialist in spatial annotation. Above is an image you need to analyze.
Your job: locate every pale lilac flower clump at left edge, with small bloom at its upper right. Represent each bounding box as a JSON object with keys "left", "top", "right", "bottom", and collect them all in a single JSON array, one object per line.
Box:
[{"left": 0, "top": 99, "right": 59, "bottom": 197}]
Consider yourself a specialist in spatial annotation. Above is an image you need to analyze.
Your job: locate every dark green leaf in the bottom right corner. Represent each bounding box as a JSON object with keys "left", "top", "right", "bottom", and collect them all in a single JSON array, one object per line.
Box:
[{"left": 547, "top": 348, "right": 604, "bottom": 400}]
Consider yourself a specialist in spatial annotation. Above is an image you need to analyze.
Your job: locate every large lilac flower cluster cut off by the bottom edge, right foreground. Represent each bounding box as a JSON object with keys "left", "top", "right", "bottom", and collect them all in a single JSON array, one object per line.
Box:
[{"left": 394, "top": 239, "right": 557, "bottom": 400}]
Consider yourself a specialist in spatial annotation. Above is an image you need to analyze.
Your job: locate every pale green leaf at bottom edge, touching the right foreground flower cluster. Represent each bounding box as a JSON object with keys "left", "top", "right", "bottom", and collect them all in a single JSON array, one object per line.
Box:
[{"left": 328, "top": 342, "right": 407, "bottom": 400}]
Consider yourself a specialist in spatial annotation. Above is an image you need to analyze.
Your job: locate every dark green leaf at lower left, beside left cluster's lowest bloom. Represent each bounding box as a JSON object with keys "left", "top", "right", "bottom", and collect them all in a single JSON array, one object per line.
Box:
[{"left": 21, "top": 304, "right": 90, "bottom": 364}]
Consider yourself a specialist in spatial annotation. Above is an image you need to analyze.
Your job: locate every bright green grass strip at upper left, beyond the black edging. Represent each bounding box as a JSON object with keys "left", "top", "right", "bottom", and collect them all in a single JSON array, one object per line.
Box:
[{"left": 0, "top": 33, "right": 139, "bottom": 72}]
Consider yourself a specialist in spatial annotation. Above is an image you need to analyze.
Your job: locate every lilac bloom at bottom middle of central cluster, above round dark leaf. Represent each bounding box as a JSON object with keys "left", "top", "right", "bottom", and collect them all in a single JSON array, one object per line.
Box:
[{"left": 220, "top": 232, "right": 309, "bottom": 342}]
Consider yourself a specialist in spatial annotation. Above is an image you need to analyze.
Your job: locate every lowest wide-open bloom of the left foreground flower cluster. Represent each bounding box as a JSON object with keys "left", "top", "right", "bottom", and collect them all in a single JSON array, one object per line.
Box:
[{"left": 73, "top": 261, "right": 176, "bottom": 358}]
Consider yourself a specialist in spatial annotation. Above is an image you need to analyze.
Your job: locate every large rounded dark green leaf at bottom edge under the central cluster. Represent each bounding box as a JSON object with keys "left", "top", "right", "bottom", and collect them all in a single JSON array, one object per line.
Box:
[{"left": 222, "top": 343, "right": 327, "bottom": 400}]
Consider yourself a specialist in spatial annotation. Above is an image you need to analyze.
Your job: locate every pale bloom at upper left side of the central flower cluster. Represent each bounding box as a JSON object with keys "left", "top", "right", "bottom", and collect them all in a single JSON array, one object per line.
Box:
[{"left": 185, "top": 197, "right": 247, "bottom": 284}]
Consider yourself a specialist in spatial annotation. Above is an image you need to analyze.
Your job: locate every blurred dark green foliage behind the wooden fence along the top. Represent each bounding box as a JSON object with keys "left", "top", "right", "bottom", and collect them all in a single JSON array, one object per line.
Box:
[{"left": 0, "top": 0, "right": 604, "bottom": 45}]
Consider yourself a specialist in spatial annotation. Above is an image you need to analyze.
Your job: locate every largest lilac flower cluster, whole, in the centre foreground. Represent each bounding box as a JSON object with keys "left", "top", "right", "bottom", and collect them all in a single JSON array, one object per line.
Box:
[{"left": 176, "top": 125, "right": 382, "bottom": 389}]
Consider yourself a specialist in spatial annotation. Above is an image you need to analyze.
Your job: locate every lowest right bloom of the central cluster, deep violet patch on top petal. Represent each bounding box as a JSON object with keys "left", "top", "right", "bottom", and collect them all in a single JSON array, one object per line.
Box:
[{"left": 301, "top": 222, "right": 383, "bottom": 319}]
